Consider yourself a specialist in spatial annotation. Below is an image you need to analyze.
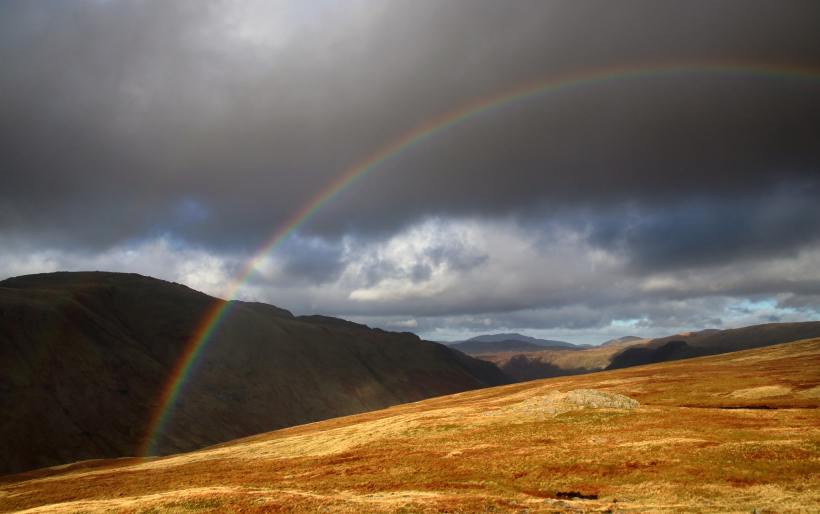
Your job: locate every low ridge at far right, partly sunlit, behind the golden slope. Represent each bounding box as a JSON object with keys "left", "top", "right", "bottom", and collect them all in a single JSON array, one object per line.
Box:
[{"left": 476, "top": 321, "right": 820, "bottom": 382}]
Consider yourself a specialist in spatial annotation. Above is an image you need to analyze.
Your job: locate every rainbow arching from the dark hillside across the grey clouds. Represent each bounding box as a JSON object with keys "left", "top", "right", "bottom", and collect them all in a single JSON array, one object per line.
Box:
[{"left": 139, "top": 62, "right": 820, "bottom": 457}]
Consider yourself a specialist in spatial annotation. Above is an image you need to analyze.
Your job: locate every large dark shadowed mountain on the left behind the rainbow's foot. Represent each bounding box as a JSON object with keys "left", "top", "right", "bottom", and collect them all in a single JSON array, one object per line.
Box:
[{"left": 0, "top": 272, "right": 512, "bottom": 474}]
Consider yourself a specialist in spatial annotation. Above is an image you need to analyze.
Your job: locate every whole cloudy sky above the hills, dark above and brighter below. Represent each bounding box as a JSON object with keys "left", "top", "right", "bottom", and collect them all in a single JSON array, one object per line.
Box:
[{"left": 0, "top": 0, "right": 820, "bottom": 344}]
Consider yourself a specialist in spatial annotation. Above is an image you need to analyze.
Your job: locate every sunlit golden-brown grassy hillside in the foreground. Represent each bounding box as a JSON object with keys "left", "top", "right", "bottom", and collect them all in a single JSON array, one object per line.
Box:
[{"left": 0, "top": 339, "right": 820, "bottom": 514}]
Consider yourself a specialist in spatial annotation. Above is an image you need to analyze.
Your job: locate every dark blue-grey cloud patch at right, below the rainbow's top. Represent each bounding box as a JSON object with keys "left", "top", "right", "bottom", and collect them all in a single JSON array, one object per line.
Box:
[{"left": 590, "top": 182, "right": 820, "bottom": 273}]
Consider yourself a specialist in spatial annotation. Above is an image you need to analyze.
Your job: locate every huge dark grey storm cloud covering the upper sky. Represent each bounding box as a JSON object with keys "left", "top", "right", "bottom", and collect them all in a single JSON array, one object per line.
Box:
[{"left": 0, "top": 0, "right": 820, "bottom": 256}]
